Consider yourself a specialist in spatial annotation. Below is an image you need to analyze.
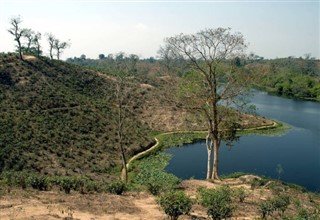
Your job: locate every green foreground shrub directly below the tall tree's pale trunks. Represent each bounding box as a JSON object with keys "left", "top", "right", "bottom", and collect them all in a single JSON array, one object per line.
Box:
[{"left": 197, "top": 186, "right": 236, "bottom": 220}]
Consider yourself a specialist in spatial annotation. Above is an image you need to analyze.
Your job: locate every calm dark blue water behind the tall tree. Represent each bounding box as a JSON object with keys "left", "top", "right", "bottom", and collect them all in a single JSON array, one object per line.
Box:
[{"left": 166, "top": 91, "right": 320, "bottom": 192}]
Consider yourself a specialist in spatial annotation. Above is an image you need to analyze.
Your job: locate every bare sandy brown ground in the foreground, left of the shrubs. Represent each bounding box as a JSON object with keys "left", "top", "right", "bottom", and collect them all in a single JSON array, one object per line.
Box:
[{"left": 0, "top": 191, "right": 165, "bottom": 220}]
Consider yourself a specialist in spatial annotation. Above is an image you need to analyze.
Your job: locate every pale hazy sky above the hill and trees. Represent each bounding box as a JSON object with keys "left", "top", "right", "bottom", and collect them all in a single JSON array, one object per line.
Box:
[{"left": 0, "top": 0, "right": 320, "bottom": 59}]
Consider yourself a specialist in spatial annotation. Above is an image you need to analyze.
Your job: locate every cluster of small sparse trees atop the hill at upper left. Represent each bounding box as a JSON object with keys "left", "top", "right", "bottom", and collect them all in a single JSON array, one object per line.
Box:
[{"left": 8, "top": 16, "right": 70, "bottom": 60}]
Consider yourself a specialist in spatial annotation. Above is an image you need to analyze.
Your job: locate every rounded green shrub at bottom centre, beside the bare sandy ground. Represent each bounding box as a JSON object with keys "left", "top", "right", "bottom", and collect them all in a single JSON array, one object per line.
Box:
[{"left": 159, "top": 191, "right": 192, "bottom": 220}]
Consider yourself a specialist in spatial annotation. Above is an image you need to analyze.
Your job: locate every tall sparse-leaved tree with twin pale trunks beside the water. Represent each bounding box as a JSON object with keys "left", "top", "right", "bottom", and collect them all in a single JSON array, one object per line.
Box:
[{"left": 163, "top": 28, "right": 249, "bottom": 179}]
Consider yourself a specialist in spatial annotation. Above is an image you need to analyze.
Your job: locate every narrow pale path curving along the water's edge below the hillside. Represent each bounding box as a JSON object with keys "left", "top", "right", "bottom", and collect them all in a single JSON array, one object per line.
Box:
[{"left": 122, "top": 121, "right": 282, "bottom": 173}]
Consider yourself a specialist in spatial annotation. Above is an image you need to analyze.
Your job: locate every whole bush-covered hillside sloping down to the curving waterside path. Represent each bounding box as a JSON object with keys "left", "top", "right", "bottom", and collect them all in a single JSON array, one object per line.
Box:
[{"left": 0, "top": 54, "right": 272, "bottom": 180}]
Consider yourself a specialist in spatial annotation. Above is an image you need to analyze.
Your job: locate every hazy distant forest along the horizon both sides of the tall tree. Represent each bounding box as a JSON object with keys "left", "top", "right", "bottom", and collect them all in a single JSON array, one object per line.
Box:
[{"left": 67, "top": 47, "right": 320, "bottom": 101}]
